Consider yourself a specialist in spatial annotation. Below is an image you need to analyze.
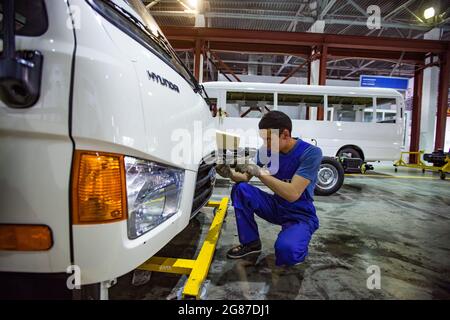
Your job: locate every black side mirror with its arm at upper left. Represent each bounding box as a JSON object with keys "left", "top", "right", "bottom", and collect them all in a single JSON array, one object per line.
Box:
[{"left": 0, "top": 0, "right": 43, "bottom": 108}]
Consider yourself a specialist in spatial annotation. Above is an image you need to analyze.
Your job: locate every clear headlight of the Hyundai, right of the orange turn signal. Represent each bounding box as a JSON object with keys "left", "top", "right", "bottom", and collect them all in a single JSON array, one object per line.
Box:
[{"left": 125, "top": 157, "right": 184, "bottom": 239}]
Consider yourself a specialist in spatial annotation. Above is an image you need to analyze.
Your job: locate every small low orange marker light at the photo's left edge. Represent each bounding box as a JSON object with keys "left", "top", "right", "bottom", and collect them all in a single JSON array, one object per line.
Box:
[{"left": 0, "top": 224, "right": 53, "bottom": 251}]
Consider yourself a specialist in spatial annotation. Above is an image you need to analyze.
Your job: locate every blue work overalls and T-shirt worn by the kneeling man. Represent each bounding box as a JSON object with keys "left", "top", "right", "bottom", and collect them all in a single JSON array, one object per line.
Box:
[{"left": 231, "top": 139, "right": 322, "bottom": 266}]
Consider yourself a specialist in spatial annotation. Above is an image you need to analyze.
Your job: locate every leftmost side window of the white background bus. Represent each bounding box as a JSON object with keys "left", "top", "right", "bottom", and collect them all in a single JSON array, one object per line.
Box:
[{"left": 227, "top": 91, "right": 273, "bottom": 118}]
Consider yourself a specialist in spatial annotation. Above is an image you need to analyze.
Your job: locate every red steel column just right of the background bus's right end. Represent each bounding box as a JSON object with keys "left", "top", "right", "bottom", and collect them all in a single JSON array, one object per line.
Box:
[{"left": 409, "top": 66, "right": 423, "bottom": 164}]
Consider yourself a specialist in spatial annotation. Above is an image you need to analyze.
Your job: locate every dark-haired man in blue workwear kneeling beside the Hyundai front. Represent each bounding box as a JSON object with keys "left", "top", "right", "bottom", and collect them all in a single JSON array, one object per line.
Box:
[{"left": 216, "top": 111, "right": 322, "bottom": 266}]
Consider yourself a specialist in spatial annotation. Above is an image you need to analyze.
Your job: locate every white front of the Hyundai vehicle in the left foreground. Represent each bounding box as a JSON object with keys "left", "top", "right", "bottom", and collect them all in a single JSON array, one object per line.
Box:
[{"left": 0, "top": 0, "right": 215, "bottom": 298}]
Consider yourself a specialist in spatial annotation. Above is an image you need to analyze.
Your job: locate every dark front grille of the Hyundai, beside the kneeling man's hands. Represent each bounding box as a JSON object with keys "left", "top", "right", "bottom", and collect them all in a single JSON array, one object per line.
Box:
[{"left": 191, "top": 161, "right": 216, "bottom": 218}]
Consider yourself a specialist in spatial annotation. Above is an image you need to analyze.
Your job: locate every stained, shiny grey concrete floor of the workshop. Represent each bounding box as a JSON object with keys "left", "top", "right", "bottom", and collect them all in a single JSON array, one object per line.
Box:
[{"left": 110, "top": 165, "right": 450, "bottom": 299}]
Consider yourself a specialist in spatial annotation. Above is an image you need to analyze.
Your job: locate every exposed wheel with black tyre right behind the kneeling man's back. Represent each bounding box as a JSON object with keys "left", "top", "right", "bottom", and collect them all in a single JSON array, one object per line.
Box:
[{"left": 314, "top": 157, "right": 344, "bottom": 196}]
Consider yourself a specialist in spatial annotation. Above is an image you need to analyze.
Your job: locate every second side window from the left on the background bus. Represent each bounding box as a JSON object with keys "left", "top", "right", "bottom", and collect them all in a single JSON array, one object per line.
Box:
[{"left": 278, "top": 93, "right": 323, "bottom": 120}]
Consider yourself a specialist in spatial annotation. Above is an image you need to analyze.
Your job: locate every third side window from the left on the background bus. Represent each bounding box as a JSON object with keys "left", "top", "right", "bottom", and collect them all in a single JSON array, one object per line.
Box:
[{"left": 328, "top": 96, "right": 373, "bottom": 122}]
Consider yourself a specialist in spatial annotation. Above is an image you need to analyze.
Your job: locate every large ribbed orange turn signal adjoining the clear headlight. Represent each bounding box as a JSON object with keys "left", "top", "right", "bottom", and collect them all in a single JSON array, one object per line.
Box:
[{"left": 72, "top": 151, "right": 127, "bottom": 224}]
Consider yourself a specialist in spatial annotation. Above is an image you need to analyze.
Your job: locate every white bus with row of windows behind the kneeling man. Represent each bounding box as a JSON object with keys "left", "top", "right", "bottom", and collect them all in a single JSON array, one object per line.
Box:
[{"left": 203, "top": 82, "right": 405, "bottom": 162}]
